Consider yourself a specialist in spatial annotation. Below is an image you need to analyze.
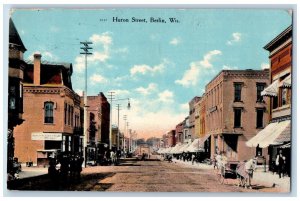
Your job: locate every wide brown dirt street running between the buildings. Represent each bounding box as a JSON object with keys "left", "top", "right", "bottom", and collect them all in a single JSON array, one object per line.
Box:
[{"left": 8, "top": 159, "right": 288, "bottom": 192}]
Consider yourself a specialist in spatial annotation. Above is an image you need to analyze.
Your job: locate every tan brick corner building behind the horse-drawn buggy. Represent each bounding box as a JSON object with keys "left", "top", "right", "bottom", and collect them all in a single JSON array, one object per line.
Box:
[{"left": 205, "top": 69, "right": 269, "bottom": 161}]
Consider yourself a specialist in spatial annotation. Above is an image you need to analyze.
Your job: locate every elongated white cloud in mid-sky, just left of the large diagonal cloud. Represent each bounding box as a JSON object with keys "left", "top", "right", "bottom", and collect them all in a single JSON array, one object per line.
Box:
[{"left": 130, "top": 59, "right": 169, "bottom": 76}]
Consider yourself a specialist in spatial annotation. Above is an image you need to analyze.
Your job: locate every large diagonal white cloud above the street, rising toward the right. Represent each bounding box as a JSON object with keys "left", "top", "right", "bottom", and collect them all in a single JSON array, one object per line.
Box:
[{"left": 175, "top": 50, "right": 222, "bottom": 87}]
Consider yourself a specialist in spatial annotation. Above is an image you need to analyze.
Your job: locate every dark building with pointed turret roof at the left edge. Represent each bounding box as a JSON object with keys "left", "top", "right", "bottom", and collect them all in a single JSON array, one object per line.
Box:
[{"left": 7, "top": 19, "right": 27, "bottom": 172}]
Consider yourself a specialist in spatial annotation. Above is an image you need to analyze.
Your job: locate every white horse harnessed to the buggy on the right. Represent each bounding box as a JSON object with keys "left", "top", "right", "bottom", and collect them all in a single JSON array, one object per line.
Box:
[{"left": 236, "top": 158, "right": 257, "bottom": 189}]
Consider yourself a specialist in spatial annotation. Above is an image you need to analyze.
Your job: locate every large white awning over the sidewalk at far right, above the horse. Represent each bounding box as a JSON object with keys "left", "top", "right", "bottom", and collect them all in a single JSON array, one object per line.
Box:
[{"left": 246, "top": 120, "right": 291, "bottom": 148}]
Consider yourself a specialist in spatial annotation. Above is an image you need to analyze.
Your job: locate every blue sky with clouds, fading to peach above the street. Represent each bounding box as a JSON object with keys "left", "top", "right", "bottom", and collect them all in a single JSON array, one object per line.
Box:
[{"left": 12, "top": 9, "right": 292, "bottom": 137}]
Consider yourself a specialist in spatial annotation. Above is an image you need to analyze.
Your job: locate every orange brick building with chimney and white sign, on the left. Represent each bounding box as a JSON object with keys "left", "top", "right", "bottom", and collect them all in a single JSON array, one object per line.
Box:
[{"left": 15, "top": 54, "right": 83, "bottom": 165}]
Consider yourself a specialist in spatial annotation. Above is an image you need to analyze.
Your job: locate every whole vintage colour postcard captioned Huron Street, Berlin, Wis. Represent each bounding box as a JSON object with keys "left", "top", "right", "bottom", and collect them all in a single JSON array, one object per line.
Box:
[{"left": 5, "top": 7, "right": 296, "bottom": 193}]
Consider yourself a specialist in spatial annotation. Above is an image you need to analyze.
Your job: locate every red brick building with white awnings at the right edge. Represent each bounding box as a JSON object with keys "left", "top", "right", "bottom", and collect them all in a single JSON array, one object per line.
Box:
[{"left": 247, "top": 26, "right": 292, "bottom": 175}]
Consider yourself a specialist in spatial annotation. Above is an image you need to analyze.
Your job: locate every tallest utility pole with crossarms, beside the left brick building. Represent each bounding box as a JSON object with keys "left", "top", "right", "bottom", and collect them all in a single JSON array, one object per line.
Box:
[{"left": 80, "top": 41, "right": 93, "bottom": 167}]
